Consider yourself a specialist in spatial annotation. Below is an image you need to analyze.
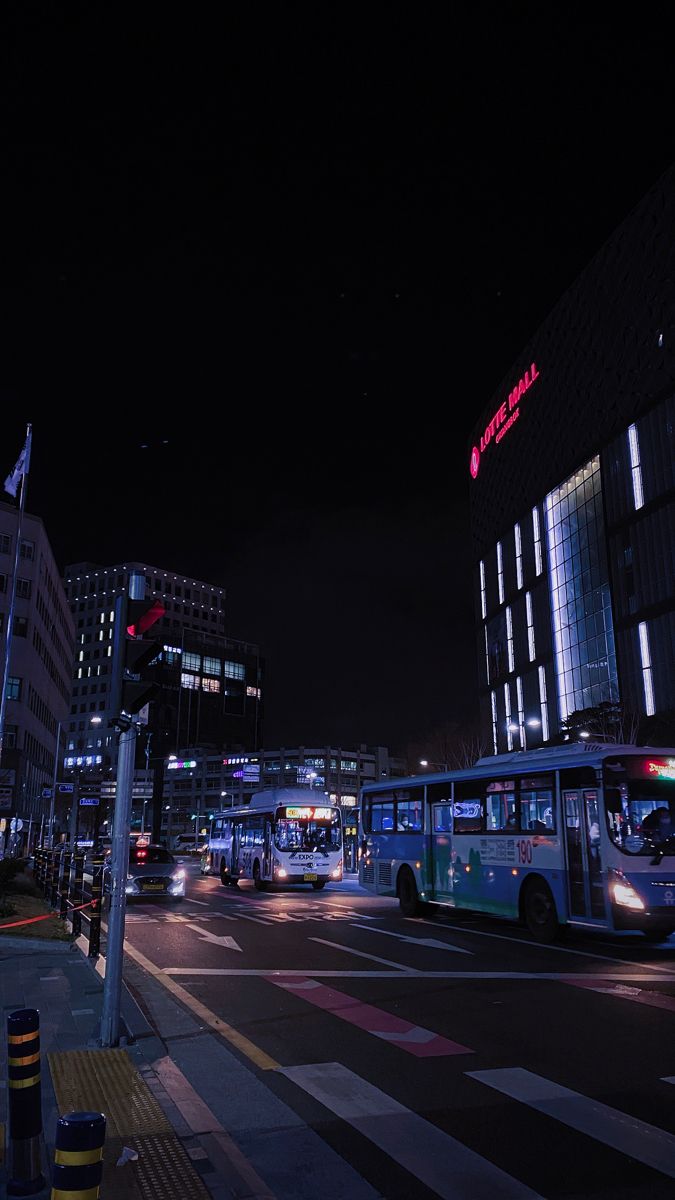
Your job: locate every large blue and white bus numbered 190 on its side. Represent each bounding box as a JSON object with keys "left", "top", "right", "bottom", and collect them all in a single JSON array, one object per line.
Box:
[{"left": 359, "top": 744, "right": 675, "bottom": 941}]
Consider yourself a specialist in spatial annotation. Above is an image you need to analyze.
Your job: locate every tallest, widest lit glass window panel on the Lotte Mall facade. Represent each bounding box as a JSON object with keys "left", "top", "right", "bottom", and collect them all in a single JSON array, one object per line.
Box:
[{"left": 545, "top": 456, "right": 619, "bottom": 721}]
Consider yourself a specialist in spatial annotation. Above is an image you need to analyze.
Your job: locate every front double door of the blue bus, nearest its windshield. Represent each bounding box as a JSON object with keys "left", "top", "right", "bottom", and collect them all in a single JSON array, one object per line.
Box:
[{"left": 562, "top": 787, "right": 607, "bottom": 924}]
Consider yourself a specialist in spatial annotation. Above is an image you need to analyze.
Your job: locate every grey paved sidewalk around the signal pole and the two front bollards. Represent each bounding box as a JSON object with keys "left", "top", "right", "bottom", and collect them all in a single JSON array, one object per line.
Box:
[{"left": 0, "top": 936, "right": 378, "bottom": 1200}]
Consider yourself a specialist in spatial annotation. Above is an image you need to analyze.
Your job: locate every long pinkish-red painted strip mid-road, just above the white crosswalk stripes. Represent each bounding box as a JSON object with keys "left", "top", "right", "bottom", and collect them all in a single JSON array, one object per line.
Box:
[{"left": 268, "top": 976, "right": 474, "bottom": 1058}]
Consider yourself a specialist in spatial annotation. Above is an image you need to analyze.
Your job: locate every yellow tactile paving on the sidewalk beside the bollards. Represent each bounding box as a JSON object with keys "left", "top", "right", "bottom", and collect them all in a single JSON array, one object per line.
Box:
[{"left": 47, "top": 1050, "right": 209, "bottom": 1200}]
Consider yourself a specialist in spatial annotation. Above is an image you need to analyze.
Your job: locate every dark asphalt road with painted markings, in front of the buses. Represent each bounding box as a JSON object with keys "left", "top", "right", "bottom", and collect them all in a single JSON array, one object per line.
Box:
[{"left": 118, "top": 863, "right": 675, "bottom": 1200}]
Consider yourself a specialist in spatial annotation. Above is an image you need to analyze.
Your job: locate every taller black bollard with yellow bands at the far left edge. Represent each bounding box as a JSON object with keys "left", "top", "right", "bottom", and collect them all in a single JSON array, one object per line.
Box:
[{"left": 7, "top": 1008, "right": 44, "bottom": 1196}]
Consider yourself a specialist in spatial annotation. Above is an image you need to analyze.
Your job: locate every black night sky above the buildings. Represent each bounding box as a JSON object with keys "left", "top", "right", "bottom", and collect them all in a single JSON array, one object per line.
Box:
[{"left": 0, "top": 11, "right": 675, "bottom": 750}]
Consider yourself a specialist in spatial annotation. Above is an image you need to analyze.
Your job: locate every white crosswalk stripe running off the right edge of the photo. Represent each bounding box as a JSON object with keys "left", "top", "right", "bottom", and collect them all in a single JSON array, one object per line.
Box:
[{"left": 466, "top": 1067, "right": 675, "bottom": 1178}]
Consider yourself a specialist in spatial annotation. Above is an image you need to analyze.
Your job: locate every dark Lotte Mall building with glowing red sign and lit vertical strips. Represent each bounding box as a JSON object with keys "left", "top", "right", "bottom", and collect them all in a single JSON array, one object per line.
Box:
[{"left": 467, "top": 167, "right": 675, "bottom": 754}]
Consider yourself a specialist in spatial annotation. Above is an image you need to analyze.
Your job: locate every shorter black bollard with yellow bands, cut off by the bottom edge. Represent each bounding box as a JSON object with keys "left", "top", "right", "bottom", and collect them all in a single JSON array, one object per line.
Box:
[{"left": 52, "top": 1112, "right": 106, "bottom": 1200}]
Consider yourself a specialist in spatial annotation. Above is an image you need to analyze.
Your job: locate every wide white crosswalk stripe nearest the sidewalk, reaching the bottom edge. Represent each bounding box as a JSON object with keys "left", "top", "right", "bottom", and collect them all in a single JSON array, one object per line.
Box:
[{"left": 280, "top": 1062, "right": 542, "bottom": 1200}]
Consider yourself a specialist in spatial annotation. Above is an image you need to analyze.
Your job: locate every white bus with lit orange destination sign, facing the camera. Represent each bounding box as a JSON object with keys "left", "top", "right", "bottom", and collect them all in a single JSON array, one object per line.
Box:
[{"left": 202, "top": 787, "right": 342, "bottom": 892}]
